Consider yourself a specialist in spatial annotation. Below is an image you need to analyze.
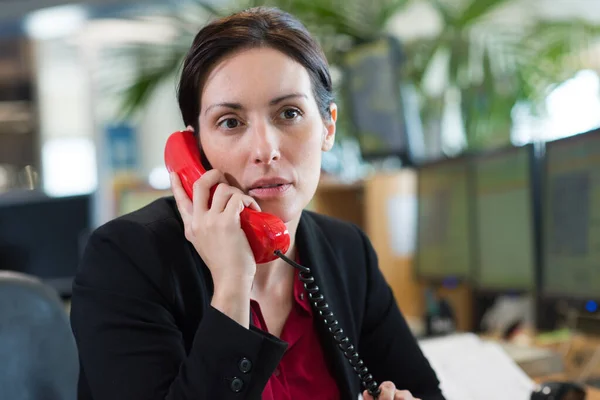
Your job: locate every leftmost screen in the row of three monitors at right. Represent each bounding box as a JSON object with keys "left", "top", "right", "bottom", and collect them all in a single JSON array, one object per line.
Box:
[{"left": 415, "top": 157, "right": 471, "bottom": 280}]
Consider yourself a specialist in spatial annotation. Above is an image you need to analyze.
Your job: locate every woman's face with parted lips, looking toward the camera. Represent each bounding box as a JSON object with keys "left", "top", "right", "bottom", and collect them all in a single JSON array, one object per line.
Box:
[{"left": 198, "top": 48, "right": 337, "bottom": 222}]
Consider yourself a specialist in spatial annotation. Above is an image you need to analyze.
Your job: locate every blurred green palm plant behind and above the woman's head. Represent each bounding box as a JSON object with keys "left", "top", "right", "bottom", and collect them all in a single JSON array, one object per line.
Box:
[{"left": 115, "top": 0, "right": 600, "bottom": 157}]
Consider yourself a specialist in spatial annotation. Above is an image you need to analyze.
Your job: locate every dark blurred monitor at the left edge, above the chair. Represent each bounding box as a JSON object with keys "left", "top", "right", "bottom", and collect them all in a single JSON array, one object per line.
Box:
[{"left": 0, "top": 192, "right": 91, "bottom": 297}]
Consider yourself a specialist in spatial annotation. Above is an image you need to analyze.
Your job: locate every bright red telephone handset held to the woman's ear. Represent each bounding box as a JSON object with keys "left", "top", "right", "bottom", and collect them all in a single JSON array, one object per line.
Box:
[{"left": 165, "top": 131, "right": 290, "bottom": 264}]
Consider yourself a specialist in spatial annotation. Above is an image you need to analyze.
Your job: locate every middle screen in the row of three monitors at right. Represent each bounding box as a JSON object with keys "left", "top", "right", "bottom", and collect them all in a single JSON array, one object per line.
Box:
[{"left": 473, "top": 145, "right": 536, "bottom": 290}]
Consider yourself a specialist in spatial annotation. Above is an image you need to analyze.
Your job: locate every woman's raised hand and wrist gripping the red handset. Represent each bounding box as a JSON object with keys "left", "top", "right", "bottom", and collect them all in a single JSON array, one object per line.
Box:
[{"left": 170, "top": 169, "right": 260, "bottom": 325}]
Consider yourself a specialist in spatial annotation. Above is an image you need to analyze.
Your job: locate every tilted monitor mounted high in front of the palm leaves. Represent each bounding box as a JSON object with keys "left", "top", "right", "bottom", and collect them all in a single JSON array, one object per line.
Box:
[{"left": 340, "top": 37, "right": 425, "bottom": 165}]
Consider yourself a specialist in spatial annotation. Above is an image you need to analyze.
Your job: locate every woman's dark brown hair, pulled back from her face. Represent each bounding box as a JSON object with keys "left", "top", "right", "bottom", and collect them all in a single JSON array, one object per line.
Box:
[{"left": 178, "top": 7, "right": 333, "bottom": 133}]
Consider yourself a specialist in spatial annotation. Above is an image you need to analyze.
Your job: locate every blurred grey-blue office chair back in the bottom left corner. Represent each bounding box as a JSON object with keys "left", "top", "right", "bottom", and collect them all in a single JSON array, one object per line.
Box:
[{"left": 0, "top": 271, "right": 79, "bottom": 400}]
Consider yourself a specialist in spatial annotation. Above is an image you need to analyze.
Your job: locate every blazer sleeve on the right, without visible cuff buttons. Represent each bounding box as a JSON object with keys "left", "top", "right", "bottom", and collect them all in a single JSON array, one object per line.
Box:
[{"left": 359, "top": 230, "right": 444, "bottom": 400}]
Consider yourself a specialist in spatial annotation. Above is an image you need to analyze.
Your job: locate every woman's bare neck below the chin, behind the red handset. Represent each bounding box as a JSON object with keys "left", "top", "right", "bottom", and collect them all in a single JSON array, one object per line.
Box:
[{"left": 252, "top": 217, "right": 300, "bottom": 295}]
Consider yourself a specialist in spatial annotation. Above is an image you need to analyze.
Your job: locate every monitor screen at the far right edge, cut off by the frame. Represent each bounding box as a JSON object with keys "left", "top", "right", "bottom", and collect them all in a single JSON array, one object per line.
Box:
[{"left": 542, "top": 131, "right": 600, "bottom": 298}]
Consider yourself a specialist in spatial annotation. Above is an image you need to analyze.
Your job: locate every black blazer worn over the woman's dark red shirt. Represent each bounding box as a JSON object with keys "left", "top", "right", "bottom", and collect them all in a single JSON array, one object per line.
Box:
[{"left": 71, "top": 197, "right": 443, "bottom": 400}]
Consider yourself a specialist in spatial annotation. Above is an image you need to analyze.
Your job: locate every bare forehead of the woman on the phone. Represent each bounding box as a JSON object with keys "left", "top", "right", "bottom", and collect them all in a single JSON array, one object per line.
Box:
[{"left": 201, "top": 47, "right": 311, "bottom": 104}]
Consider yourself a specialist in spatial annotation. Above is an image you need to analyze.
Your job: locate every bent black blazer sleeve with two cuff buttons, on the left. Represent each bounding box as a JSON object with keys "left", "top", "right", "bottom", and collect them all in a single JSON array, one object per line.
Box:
[{"left": 71, "top": 221, "right": 287, "bottom": 400}]
